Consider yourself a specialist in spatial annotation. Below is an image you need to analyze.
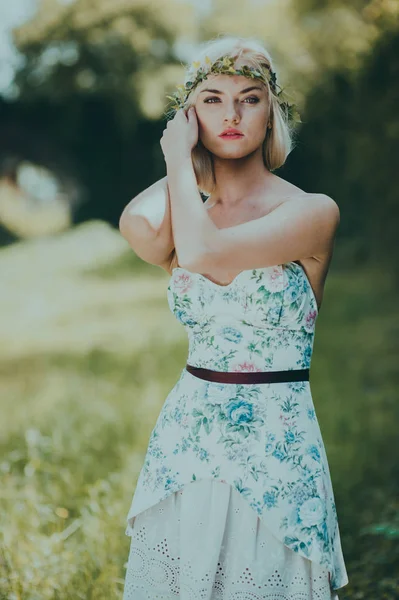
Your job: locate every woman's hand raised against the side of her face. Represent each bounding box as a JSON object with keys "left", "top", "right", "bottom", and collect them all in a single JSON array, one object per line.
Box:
[{"left": 161, "top": 106, "right": 198, "bottom": 163}]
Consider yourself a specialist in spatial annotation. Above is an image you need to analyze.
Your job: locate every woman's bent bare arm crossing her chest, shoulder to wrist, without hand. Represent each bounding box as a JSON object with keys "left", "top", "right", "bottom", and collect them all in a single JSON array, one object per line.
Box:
[{"left": 168, "top": 159, "right": 340, "bottom": 273}]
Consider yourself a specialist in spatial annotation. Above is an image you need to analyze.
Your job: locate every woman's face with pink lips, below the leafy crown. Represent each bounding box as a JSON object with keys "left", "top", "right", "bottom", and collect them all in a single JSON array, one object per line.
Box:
[{"left": 194, "top": 74, "right": 269, "bottom": 158}]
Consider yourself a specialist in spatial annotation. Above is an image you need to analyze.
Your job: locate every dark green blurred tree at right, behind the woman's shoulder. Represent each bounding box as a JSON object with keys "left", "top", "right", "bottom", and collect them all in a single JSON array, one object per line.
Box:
[{"left": 287, "top": 21, "right": 399, "bottom": 276}]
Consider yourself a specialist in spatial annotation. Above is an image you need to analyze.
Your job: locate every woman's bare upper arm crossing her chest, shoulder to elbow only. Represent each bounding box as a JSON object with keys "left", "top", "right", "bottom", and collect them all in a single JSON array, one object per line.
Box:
[{"left": 191, "top": 194, "right": 340, "bottom": 272}]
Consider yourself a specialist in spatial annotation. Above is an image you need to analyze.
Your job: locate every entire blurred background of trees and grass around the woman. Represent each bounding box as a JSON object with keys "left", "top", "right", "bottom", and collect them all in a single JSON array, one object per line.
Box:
[{"left": 0, "top": 0, "right": 399, "bottom": 600}]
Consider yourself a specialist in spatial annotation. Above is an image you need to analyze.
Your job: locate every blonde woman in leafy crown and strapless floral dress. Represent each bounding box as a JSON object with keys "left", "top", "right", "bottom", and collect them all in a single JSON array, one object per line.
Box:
[{"left": 120, "top": 36, "right": 348, "bottom": 600}]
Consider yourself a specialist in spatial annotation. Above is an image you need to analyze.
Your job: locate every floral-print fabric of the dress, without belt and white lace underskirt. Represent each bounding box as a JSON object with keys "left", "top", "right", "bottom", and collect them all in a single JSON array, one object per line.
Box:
[{"left": 126, "top": 262, "right": 348, "bottom": 590}]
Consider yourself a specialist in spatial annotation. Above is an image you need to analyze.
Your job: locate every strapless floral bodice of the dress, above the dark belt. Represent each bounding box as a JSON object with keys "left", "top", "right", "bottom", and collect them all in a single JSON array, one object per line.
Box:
[{"left": 167, "top": 262, "right": 318, "bottom": 372}]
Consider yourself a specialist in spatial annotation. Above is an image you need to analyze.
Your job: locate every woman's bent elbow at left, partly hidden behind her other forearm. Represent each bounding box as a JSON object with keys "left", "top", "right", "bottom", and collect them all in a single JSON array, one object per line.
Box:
[{"left": 119, "top": 176, "right": 176, "bottom": 273}]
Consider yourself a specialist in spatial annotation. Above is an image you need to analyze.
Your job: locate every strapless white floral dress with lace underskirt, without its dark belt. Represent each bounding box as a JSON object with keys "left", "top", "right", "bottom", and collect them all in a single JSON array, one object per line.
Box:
[{"left": 123, "top": 262, "right": 348, "bottom": 600}]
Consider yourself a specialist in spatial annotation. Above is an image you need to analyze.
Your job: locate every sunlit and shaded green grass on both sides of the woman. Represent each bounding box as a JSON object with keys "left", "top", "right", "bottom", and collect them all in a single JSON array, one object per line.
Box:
[{"left": 0, "top": 222, "right": 399, "bottom": 600}]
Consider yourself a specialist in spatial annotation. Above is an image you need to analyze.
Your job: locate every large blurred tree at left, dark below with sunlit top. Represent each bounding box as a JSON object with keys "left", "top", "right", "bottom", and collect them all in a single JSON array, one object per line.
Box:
[{"left": 0, "top": 0, "right": 195, "bottom": 225}]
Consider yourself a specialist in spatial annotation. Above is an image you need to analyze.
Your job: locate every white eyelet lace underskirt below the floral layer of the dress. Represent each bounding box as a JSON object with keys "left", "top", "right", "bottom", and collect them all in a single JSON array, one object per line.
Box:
[{"left": 123, "top": 478, "right": 338, "bottom": 600}]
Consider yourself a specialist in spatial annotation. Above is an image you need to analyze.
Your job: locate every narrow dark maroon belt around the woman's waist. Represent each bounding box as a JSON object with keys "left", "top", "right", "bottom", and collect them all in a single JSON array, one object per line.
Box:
[{"left": 186, "top": 364, "right": 309, "bottom": 383}]
